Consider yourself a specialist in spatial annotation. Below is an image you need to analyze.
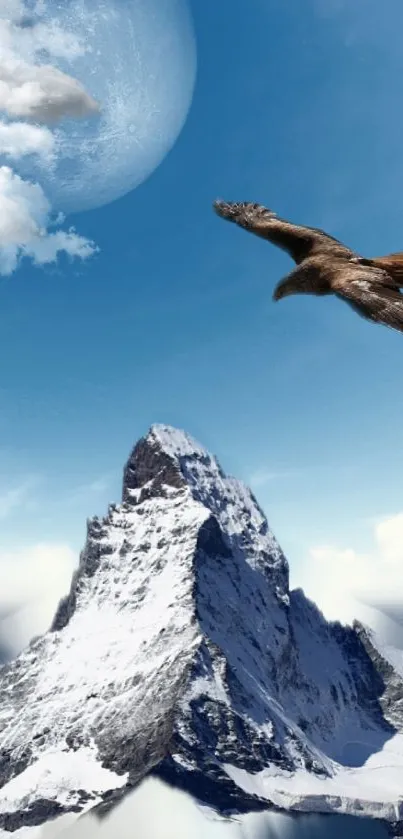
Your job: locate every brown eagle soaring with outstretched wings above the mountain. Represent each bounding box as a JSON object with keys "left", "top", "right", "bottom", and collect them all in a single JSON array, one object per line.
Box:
[{"left": 213, "top": 201, "right": 403, "bottom": 332}]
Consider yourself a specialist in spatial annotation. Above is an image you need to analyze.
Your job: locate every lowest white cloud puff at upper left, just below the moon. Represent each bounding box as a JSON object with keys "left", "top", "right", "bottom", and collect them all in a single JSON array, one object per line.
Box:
[{"left": 0, "top": 166, "right": 97, "bottom": 275}]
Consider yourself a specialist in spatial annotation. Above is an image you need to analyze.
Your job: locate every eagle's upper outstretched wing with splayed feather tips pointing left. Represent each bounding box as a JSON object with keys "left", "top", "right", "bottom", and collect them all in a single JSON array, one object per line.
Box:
[{"left": 214, "top": 201, "right": 354, "bottom": 264}]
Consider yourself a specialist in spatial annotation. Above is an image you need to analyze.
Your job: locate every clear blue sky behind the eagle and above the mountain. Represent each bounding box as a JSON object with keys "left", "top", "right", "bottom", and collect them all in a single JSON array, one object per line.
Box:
[{"left": 0, "top": 0, "right": 403, "bottom": 624}]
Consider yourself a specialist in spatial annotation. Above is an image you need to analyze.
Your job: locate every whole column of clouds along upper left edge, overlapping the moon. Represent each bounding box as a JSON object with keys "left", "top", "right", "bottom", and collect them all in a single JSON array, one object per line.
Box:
[{"left": 0, "top": 0, "right": 99, "bottom": 275}]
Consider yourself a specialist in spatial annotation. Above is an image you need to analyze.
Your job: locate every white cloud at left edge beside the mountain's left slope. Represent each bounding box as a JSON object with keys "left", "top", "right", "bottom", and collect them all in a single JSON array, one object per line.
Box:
[{"left": 0, "top": 544, "right": 77, "bottom": 654}]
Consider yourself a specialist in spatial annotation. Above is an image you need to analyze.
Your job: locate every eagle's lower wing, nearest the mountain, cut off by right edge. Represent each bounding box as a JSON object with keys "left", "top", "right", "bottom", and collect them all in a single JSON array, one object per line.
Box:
[{"left": 332, "top": 272, "right": 403, "bottom": 332}]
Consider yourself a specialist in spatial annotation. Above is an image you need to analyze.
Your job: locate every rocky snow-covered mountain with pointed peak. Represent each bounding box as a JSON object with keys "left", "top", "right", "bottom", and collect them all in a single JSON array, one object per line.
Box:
[{"left": 0, "top": 425, "right": 403, "bottom": 836}]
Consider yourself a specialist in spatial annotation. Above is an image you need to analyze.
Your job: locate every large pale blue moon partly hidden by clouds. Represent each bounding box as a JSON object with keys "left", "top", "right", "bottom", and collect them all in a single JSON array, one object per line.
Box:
[{"left": 11, "top": 0, "right": 196, "bottom": 213}]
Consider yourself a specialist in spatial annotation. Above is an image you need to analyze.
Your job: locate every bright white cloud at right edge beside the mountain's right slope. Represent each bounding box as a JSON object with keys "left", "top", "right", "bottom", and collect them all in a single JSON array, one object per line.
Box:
[{"left": 298, "top": 513, "right": 403, "bottom": 632}]
